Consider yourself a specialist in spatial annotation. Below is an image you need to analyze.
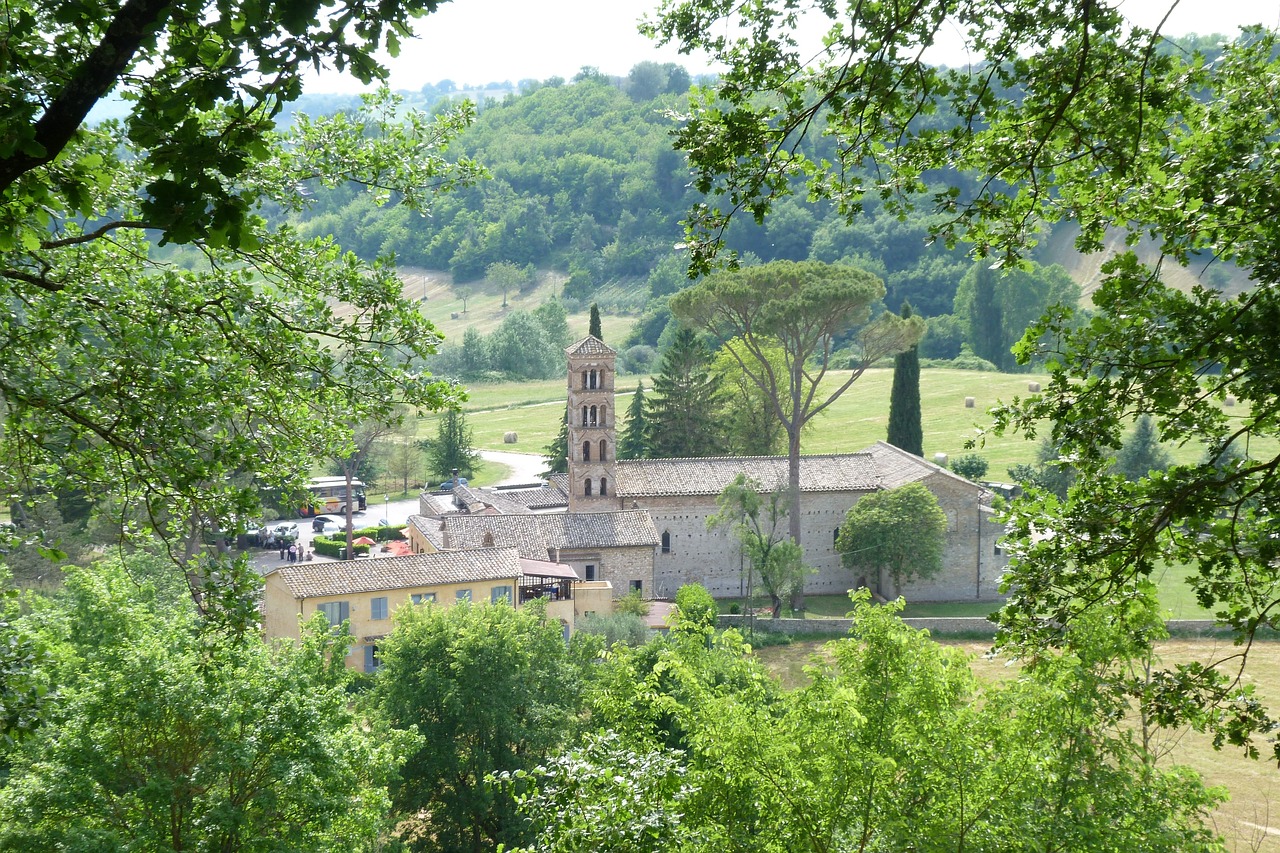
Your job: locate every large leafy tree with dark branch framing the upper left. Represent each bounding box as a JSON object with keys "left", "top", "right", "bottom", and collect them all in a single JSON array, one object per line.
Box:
[{"left": 0, "top": 0, "right": 483, "bottom": 615}]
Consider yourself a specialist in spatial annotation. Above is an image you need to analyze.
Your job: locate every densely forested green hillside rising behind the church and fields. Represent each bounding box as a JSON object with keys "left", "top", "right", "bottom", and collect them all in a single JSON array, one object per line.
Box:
[{"left": 272, "top": 54, "right": 1245, "bottom": 371}]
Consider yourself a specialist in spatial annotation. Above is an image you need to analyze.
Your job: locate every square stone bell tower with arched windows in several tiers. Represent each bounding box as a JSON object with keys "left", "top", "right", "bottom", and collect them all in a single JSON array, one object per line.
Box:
[{"left": 564, "top": 334, "right": 618, "bottom": 512}]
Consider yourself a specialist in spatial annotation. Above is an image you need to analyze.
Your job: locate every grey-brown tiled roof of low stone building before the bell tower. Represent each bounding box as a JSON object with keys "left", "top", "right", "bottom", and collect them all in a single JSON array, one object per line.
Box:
[{"left": 442, "top": 510, "right": 658, "bottom": 560}]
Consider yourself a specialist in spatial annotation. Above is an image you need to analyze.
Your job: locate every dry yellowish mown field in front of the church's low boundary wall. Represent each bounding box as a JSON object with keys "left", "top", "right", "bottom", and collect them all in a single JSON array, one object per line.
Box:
[{"left": 755, "top": 638, "right": 1280, "bottom": 853}]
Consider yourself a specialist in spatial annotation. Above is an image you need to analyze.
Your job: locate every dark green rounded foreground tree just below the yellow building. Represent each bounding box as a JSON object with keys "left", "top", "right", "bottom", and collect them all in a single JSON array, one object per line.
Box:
[{"left": 370, "top": 603, "right": 581, "bottom": 853}]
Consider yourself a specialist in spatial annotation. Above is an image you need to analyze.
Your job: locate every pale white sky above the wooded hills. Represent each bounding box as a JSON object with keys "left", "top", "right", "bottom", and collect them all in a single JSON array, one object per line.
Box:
[{"left": 307, "top": 0, "right": 1280, "bottom": 93}]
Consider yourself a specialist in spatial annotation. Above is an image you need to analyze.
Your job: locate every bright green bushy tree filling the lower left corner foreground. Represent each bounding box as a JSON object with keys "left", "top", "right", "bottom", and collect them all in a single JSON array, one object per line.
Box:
[{"left": 0, "top": 553, "right": 409, "bottom": 850}]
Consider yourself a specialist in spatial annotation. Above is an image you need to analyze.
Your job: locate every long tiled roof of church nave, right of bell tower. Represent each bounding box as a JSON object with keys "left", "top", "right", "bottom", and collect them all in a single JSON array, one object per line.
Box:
[{"left": 617, "top": 452, "right": 881, "bottom": 498}]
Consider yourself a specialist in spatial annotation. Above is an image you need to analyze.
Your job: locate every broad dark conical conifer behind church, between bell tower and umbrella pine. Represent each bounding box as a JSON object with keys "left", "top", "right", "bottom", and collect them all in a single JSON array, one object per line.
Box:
[{"left": 644, "top": 327, "right": 724, "bottom": 459}]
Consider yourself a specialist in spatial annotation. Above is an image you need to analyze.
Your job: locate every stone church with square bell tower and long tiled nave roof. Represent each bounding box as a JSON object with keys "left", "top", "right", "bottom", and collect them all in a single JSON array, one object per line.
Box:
[{"left": 562, "top": 336, "right": 1006, "bottom": 601}]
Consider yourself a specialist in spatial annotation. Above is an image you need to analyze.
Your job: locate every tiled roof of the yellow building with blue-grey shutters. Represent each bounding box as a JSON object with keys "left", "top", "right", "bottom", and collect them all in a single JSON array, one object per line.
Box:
[{"left": 276, "top": 548, "right": 520, "bottom": 598}]
